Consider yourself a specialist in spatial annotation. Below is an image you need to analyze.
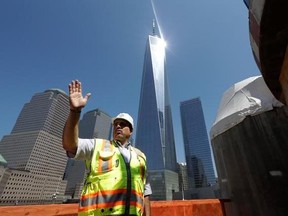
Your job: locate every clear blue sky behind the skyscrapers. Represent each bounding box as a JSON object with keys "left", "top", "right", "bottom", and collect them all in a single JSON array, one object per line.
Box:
[{"left": 0, "top": 0, "right": 260, "bottom": 162}]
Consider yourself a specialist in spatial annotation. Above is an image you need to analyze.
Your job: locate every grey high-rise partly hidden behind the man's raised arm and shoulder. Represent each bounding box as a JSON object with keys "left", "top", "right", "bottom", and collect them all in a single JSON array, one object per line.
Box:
[{"left": 64, "top": 109, "right": 112, "bottom": 199}]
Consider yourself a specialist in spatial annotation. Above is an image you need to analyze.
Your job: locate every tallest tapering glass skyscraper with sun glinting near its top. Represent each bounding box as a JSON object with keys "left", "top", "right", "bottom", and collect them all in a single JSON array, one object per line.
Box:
[{"left": 135, "top": 31, "right": 179, "bottom": 200}]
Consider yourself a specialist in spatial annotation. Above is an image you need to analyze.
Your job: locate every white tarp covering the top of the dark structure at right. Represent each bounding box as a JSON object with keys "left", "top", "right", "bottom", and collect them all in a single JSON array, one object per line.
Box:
[{"left": 210, "top": 76, "right": 283, "bottom": 139}]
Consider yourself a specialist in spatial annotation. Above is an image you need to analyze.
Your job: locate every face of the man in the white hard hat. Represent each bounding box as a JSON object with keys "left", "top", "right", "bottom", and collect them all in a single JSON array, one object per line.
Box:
[{"left": 113, "top": 119, "right": 132, "bottom": 144}]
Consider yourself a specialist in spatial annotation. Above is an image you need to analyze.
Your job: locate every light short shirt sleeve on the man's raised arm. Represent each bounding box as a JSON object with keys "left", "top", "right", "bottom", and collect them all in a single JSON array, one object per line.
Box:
[{"left": 67, "top": 138, "right": 95, "bottom": 160}]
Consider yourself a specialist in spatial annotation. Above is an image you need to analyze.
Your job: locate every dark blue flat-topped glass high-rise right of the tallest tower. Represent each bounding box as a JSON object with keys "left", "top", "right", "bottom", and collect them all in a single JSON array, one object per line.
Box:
[{"left": 180, "top": 98, "right": 216, "bottom": 188}]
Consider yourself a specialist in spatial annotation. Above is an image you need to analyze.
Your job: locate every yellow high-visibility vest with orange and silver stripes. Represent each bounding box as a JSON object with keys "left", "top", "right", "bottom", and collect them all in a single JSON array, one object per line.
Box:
[{"left": 78, "top": 139, "right": 146, "bottom": 216}]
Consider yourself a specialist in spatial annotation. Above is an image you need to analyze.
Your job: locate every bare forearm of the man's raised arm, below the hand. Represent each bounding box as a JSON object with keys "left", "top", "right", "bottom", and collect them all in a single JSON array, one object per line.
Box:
[{"left": 62, "top": 111, "right": 80, "bottom": 154}]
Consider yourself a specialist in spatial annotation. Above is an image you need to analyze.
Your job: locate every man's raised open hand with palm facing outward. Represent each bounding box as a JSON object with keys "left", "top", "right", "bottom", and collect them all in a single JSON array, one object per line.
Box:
[{"left": 69, "top": 80, "right": 91, "bottom": 111}]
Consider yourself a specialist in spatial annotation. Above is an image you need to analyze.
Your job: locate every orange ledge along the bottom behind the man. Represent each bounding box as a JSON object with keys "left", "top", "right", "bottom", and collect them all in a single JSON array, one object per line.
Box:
[{"left": 0, "top": 199, "right": 225, "bottom": 216}]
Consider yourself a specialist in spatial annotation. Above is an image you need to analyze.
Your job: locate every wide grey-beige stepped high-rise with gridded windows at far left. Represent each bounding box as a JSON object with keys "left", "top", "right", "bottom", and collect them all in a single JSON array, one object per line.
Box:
[{"left": 0, "top": 89, "right": 69, "bottom": 203}]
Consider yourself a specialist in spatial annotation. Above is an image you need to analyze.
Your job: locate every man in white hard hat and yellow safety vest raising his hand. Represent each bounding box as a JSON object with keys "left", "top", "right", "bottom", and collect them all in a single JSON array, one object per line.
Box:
[{"left": 63, "top": 80, "right": 152, "bottom": 216}]
